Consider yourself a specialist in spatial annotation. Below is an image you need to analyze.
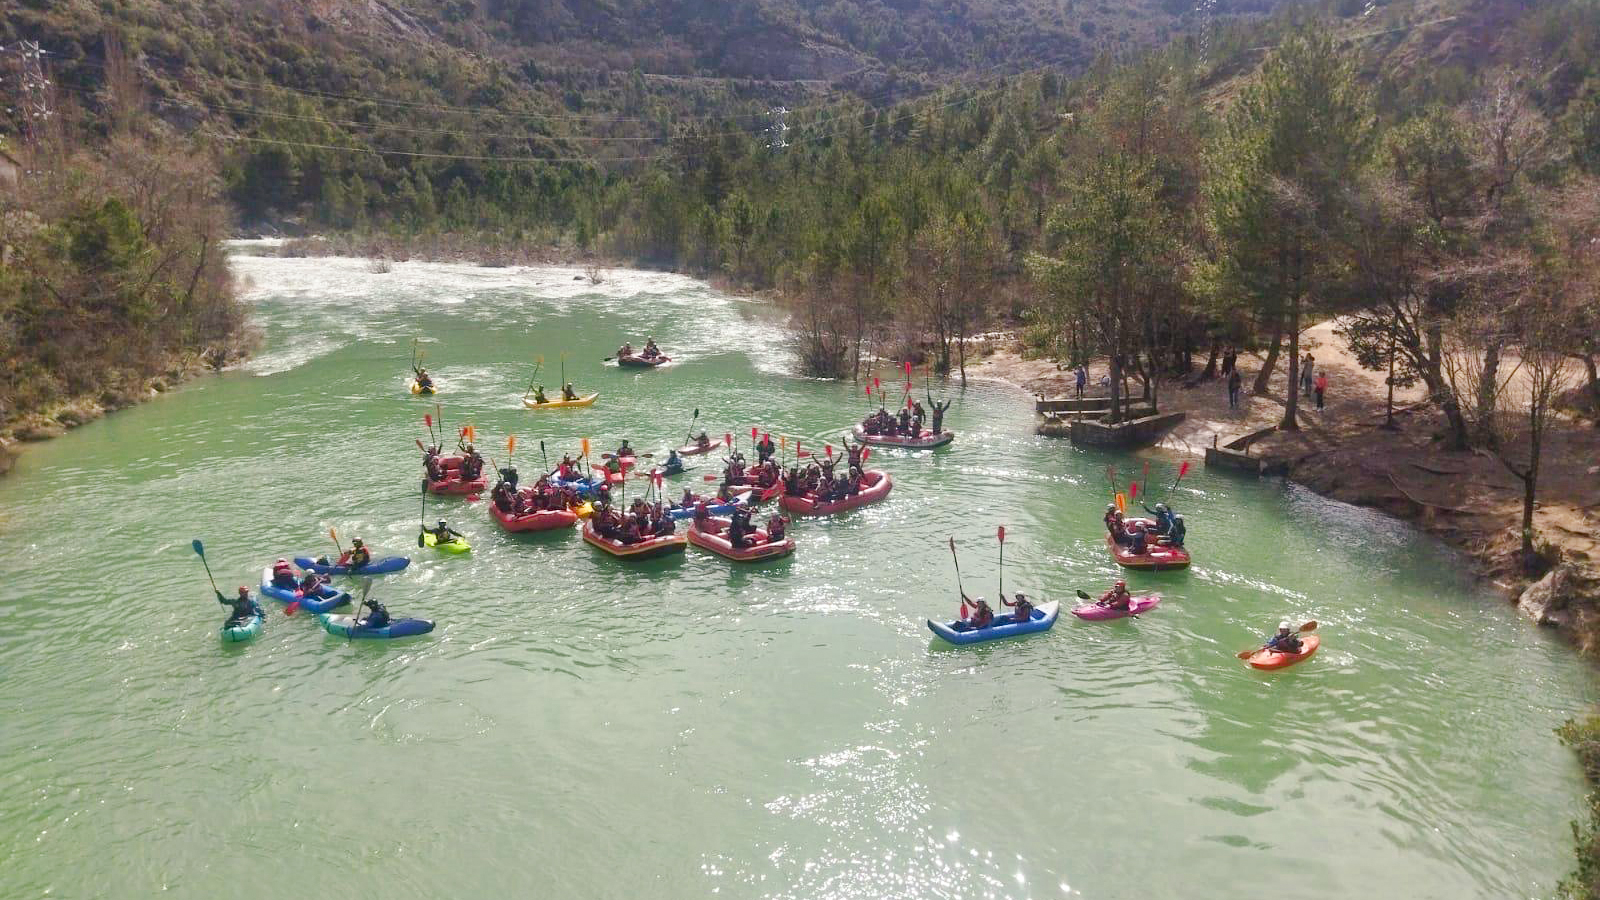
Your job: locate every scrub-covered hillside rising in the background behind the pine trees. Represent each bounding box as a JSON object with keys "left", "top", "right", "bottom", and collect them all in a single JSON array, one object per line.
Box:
[{"left": 0, "top": 0, "right": 1277, "bottom": 231}]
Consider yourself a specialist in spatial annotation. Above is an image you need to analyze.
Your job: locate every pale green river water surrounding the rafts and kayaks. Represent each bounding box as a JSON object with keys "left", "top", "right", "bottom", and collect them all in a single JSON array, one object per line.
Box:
[{"left": 0, "top": 248, "right": 1597, "bottom": 900}]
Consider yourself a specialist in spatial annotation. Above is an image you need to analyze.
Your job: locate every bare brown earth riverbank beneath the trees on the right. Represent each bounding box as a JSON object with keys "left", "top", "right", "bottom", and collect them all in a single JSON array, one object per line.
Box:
[{"left": 968, "top": 323, "right": 1600, "bottom": 657}]
